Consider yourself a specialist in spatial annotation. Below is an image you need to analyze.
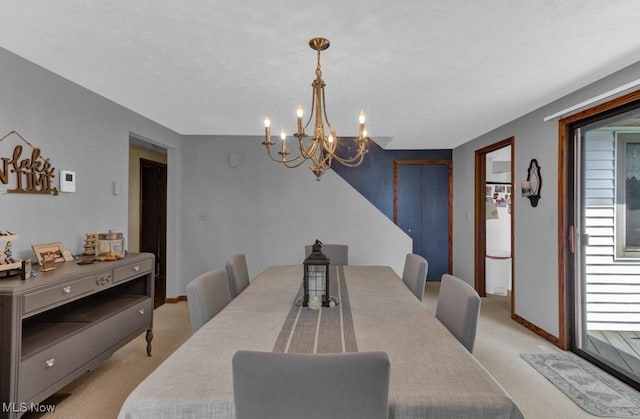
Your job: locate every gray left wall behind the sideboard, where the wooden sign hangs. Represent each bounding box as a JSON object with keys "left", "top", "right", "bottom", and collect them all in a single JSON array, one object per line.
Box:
[{"left": 0, "top": 48, "right": 180, "bottom": 294}]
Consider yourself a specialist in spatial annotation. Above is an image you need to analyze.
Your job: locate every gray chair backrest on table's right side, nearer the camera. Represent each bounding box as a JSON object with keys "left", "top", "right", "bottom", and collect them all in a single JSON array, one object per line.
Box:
[{"left": 436, "top": 274, "right": 480, "bottom": 352}]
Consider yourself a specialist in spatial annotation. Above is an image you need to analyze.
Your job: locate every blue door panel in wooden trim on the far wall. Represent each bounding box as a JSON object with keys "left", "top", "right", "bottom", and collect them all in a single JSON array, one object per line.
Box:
[{"left": 394, "top": 160, "right": 452, "bottom": 281}]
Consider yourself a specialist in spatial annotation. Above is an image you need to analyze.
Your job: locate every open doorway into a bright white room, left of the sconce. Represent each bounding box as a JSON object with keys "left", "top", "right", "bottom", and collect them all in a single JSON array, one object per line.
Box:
[{"left": 474, "top": 137, "right": 515, "bottom": 306}]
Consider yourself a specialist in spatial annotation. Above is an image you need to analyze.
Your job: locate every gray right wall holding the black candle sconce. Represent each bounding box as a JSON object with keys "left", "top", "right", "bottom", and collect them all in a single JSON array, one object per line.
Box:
[{"left": 453, "top": 59, "right": 640, "bottom": 336}]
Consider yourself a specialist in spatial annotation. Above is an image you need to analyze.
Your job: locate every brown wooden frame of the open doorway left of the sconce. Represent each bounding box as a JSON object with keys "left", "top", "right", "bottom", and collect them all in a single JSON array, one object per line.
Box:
[{"left": 474, "top": 137, "right": 516, "bottom": 306}]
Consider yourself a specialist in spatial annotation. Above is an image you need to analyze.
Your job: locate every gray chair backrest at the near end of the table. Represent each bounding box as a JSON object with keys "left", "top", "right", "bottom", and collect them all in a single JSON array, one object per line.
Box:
[{"left": 232, "top": 351, "right": 390, "bottom": 419}]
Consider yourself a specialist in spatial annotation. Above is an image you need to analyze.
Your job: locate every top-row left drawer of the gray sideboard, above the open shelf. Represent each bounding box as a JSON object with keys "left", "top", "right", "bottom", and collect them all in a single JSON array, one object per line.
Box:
[{"left": 22, "top": 275, "right": 96, "bottom": 314}]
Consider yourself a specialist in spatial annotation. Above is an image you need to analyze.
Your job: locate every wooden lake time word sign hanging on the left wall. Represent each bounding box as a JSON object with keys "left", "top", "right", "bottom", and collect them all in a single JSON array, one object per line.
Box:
[{"left": 0, "top": 131, "right": 58, "bottom": 195}]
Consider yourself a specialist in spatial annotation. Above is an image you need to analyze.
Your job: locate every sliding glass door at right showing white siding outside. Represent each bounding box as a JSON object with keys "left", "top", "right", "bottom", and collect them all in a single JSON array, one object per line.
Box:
[{"left": 569, "top": 104, "right": 640, "bottom": 388}]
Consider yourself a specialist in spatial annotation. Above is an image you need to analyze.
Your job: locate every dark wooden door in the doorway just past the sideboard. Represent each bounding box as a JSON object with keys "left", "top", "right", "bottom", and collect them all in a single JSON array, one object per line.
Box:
[{"left": 140, "top": 159, "right": 167, "bottom": 308}]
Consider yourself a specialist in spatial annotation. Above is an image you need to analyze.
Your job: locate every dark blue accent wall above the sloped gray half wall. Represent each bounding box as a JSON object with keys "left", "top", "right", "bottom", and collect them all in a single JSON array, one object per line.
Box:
[{"left": 331, "top": 141, "right": 451, "bottom": 220}]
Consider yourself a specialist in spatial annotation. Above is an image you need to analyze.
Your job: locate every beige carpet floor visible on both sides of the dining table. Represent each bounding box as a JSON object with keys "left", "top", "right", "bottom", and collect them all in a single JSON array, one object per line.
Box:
[{"left": 24, "top": 283, "right": 640, "bottom": 419}]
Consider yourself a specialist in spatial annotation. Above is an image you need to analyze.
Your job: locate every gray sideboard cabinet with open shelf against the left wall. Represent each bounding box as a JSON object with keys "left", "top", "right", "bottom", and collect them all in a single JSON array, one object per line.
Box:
[{"left": 0, "top": 253, "right": 155, "bottom": 418}]
